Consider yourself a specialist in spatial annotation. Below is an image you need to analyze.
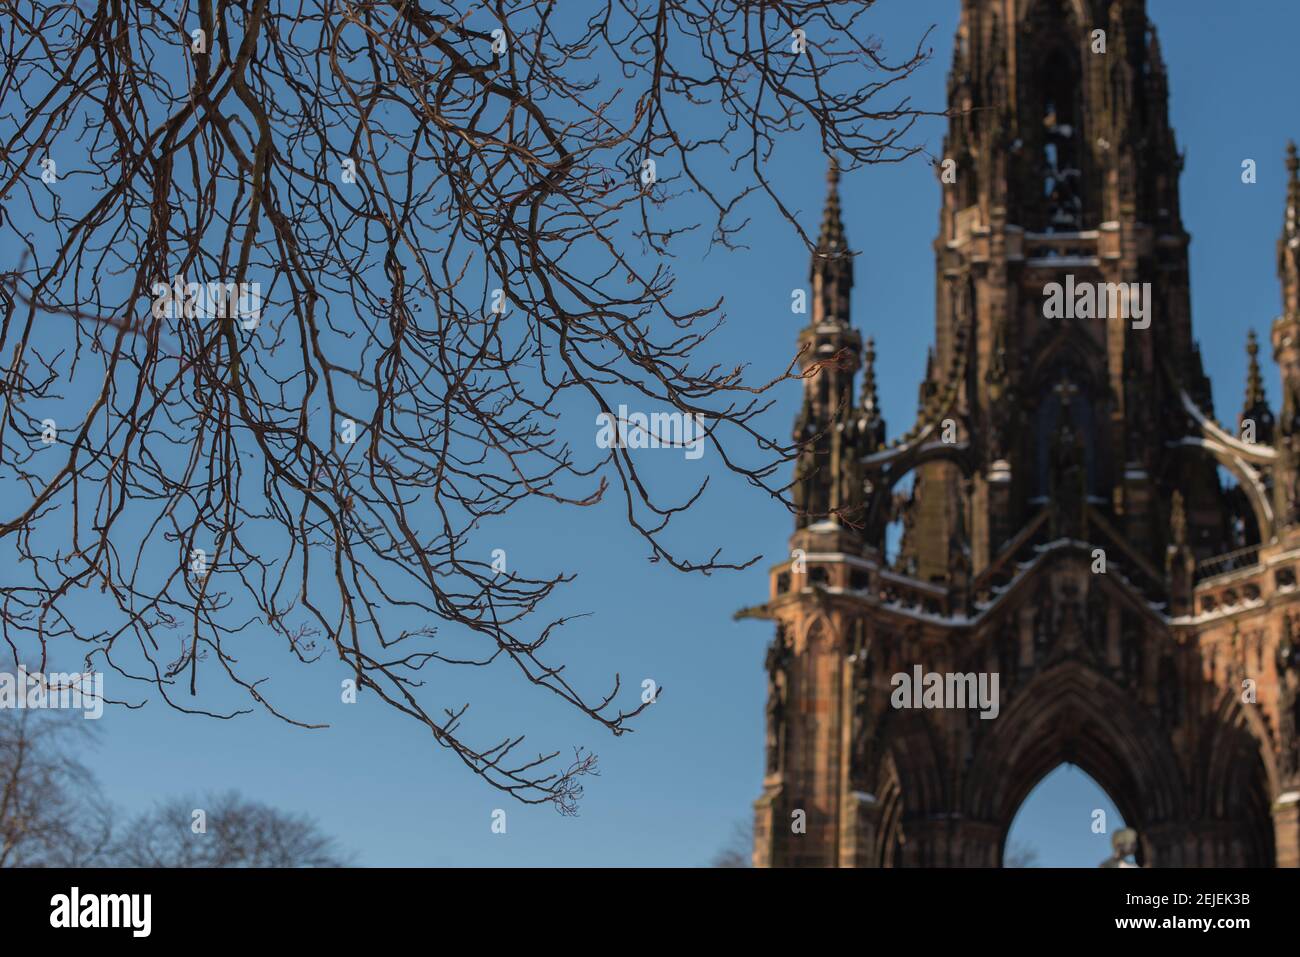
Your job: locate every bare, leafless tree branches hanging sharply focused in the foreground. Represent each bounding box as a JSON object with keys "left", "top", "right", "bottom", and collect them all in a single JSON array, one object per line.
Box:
[{"left": 0, "top": 0, "right": 927, "bottom": 813}]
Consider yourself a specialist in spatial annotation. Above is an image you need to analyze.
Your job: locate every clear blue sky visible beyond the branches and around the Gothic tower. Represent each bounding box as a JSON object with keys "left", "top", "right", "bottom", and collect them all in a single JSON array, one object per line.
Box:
[{"left": 40, "top": 0, "right": 1300, "bottom": 866}]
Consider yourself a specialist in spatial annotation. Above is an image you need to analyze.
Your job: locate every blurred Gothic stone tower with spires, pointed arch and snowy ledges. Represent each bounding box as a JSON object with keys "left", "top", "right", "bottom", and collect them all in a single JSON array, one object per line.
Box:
[{"left": 741, "top": 0, "right": 1300, "bottom": 867}]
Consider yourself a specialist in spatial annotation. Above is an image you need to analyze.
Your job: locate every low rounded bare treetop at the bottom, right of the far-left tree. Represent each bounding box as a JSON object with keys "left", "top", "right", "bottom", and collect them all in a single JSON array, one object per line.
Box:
[{"left": 113, "top": 792, "right": 351, "bottom": 867}]
